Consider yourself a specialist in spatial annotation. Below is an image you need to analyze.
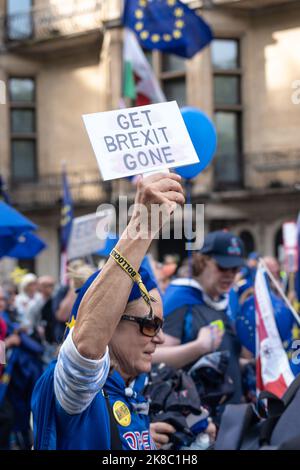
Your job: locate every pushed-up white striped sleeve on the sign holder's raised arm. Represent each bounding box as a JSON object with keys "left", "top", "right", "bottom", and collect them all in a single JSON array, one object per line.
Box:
[{"left": 54, "top": 329, "right": 110, "bottom": 415}]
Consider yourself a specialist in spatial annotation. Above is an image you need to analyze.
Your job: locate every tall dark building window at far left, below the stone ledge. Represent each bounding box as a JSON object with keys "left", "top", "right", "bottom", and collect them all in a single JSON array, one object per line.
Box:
[{"left": 9, "top": 77, "right": 37, "bottom": 182}]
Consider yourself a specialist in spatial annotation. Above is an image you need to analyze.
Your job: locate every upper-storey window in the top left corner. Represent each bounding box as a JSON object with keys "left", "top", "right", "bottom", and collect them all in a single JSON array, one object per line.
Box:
[{"left": 6, "top": 0, "right": 33, "bottom": 41}]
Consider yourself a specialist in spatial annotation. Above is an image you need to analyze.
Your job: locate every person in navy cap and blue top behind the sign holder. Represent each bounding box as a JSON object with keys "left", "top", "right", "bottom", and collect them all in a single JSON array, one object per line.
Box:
[{"left": 153, "top": 230, "right": 244, "bottom": 403}]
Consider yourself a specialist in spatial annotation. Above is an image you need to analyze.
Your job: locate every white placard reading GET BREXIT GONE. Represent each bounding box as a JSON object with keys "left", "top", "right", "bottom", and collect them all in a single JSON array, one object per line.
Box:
[{"left": 83, "top": 101, "right": 199, "bottom": 180}]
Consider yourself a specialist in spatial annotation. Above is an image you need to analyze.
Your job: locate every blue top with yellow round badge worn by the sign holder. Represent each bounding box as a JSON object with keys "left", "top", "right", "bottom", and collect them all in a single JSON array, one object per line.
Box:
[{"left": 32, "top": 361, "right": 155, "bottom": 450}]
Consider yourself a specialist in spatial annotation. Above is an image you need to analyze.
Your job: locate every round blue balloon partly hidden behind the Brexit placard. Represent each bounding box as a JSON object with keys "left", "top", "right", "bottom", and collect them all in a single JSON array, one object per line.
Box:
[{"left": 176, "top": 107, "right": 217, "bottom": 180}]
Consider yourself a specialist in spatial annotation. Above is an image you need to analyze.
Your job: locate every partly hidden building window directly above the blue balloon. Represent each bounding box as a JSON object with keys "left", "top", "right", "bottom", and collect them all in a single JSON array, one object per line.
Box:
[{"left": 158, "top": 54, "right": 186, "bottom": 106}]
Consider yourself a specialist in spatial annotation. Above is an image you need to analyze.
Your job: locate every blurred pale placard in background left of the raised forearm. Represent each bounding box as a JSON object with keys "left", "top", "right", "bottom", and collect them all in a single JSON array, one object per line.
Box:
[{"left": 68, "top": 210, "right": 112, "bottom": 260}]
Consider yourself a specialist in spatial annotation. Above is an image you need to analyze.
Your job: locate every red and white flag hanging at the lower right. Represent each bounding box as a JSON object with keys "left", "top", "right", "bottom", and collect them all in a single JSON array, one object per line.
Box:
[{"left": 254, "top": 263, "right": 295, "bottom": 398}]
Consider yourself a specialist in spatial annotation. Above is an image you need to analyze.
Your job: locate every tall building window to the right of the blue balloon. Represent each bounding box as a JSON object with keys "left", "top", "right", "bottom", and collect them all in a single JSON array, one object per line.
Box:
[{"left": 211, "top": 39, "right": 243, "bottom": 190}]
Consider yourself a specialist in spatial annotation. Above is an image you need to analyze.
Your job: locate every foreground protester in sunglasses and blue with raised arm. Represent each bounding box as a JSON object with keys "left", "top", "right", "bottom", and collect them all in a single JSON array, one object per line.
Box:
[{"left": 32, "top": 174, "right": 184, "bottom": 450}]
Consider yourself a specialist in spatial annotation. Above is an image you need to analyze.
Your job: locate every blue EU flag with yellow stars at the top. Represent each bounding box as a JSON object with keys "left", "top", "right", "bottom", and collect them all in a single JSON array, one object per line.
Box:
[{"left": 123, "top": 0, "right": 213, "bottom": 59}]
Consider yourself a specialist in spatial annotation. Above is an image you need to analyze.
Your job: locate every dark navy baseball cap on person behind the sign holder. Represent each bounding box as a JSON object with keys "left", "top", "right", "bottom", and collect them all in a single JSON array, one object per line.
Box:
[{"left": 200, "top": 230, "right": 244, "bottom": 269}]
